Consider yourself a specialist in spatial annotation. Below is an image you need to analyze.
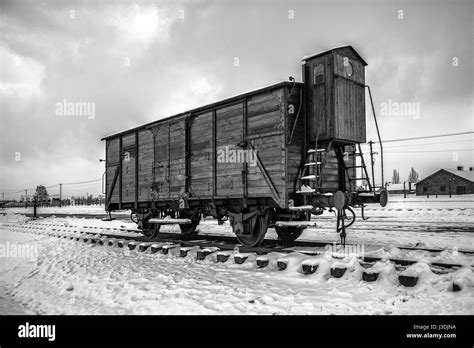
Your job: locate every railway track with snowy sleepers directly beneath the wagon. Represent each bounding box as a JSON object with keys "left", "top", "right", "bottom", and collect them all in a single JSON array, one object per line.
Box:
[{"left": 2, "top": 220, "right": 474, "bottom": 291}]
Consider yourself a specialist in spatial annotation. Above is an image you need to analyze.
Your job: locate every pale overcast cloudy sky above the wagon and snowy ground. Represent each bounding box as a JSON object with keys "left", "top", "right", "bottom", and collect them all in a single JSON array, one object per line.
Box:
[{"left": 0, "top": 0, "right": 474, "bottom": 196}]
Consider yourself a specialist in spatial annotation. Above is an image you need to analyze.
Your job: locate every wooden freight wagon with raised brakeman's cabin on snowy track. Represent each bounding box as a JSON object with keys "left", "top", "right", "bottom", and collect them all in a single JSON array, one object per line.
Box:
[{"left": 103, "top": 47, "right": 386, "bottom": 246}]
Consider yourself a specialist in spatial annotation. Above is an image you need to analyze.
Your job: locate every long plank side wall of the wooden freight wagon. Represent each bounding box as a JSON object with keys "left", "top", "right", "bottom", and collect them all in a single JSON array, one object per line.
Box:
[{"left": 104, "top": 82, "right": 303, "bottom": 209}]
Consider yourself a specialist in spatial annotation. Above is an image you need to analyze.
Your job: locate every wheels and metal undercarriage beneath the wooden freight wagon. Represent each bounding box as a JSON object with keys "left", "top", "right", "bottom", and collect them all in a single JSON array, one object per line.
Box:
[{"left": 131, "top": 185, "right": 387, "bottom": 247}]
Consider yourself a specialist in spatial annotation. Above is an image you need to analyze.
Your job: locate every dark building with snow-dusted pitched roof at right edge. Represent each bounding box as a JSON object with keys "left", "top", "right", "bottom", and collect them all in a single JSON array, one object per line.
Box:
[{"left": 416, "top": 167, "right": 474, "bottom": 195}]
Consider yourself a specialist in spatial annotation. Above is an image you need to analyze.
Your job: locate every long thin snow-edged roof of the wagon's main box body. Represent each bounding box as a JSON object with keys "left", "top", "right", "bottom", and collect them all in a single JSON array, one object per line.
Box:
[{"left": 101, "top": 81, "right": 303, "bottom": 140}]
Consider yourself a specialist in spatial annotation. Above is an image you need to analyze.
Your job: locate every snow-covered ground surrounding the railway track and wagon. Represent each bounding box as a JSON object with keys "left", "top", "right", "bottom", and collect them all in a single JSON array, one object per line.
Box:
[{"left": 0, "top": 196, "right": 474, "bottom": 315}]
